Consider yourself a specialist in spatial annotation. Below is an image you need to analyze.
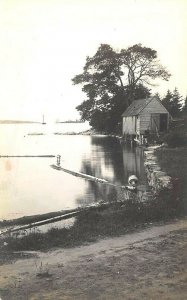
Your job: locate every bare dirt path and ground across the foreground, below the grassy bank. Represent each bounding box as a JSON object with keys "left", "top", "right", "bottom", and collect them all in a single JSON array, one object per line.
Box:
[{"left": 0, "top": 219, "right": 187, "bottom": 300}]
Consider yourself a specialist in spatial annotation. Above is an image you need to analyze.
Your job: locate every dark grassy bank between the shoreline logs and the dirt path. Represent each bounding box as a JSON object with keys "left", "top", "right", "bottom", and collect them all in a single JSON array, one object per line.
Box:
[{"left": 0, "top": 195, "right": 181, "bottom": 253}]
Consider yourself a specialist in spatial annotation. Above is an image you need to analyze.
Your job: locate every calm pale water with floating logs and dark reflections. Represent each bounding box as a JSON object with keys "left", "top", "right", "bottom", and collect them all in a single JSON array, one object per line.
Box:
[{"left": 0, "top": 123, "right": 145, "bottom": 219}]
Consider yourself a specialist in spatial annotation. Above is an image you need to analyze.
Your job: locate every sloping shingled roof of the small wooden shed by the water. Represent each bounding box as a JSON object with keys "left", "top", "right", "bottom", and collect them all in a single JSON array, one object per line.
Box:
[{"left": 122, "top": 97, "right": 154, "bottom": 117}]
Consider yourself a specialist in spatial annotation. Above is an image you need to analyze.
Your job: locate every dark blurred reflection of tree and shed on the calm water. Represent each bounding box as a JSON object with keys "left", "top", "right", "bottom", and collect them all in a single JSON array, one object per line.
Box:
[{"left": 77, "top": 137, "right": 143, "bottom": 205}]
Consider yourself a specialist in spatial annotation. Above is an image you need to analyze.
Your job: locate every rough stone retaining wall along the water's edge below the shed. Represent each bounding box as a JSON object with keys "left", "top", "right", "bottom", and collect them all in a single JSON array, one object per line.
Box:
[{"left": 144, "top": 146, "right": 173, "bottom": 193}]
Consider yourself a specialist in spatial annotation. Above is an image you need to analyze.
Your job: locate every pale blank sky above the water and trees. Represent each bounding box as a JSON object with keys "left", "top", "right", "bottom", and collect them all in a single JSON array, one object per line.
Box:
[{"left": 0, "top": 0, "right": 187, "bottom": 121}]
